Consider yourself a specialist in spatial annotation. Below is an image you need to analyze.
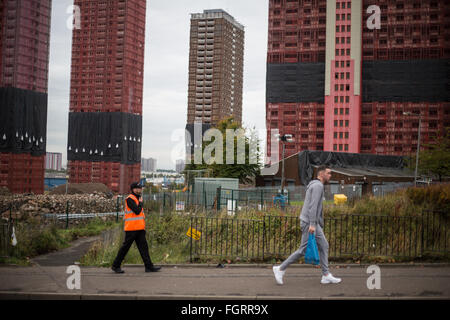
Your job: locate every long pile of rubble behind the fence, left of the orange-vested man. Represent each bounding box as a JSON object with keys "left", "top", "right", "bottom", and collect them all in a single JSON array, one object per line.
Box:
[{"left": 0, "top": 192, "right": 122, "bottom": 221}]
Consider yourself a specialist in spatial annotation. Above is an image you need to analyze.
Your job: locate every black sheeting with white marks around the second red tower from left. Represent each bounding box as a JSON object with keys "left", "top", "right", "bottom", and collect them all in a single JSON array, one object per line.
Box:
[{"left": 67, "top": 112, "right": 142, "bottom": 164}]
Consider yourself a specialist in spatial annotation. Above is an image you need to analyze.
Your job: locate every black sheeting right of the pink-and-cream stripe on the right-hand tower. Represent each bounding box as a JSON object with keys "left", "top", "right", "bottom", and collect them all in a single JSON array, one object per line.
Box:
[{"left": 362, "top": 59, "right": 450, "bottom": 102}]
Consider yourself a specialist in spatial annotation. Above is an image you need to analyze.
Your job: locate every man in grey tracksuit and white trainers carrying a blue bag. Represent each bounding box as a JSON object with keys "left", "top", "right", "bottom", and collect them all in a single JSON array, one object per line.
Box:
[{"left": 273, "top": 166, "right": 341, "bottom": 284}]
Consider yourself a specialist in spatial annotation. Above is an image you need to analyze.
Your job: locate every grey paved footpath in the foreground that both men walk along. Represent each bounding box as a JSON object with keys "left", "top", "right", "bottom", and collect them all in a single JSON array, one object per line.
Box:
[{"left": 0, "top": 264, "right": 450, "bottom": 300}]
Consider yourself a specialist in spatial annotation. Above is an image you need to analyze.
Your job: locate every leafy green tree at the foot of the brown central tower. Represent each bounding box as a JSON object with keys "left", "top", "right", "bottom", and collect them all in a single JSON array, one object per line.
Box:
[{"left": 185, "top": 117, "right": 261, "bottom": 183}]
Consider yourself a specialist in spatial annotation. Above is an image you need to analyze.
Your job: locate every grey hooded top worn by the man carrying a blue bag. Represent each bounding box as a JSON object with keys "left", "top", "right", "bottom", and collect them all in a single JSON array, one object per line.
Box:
[{"left": 300, "top": 180, "right": 324, "bottom": 228}]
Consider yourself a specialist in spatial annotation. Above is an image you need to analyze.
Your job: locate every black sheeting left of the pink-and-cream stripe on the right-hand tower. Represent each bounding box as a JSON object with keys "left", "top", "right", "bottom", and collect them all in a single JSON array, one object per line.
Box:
[{"left": 266, "top": 62, "right": 325, "bottom": 103}]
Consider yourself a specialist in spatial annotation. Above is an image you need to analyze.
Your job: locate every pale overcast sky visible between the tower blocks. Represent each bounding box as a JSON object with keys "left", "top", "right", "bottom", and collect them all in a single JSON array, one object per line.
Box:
[{"left": 47, "top": 0, "right": 268, "bottom": 169}]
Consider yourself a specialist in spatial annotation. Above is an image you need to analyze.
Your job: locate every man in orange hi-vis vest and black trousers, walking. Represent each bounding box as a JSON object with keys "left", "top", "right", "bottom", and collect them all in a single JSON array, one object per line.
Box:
[{"left": 111, "top": 182, "right": 161, "bottom": 273}]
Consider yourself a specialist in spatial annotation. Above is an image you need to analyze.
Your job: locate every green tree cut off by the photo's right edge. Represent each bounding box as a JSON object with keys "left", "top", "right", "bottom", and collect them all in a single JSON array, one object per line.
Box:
[{"left": 409, "top": 128, "right": 450, "bottom": 181}]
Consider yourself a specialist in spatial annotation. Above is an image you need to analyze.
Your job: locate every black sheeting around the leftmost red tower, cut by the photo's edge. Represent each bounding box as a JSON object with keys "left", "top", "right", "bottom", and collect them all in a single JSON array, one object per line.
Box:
[{"left": 0, "top": 87, "right": 47, "bottom": 156}]
